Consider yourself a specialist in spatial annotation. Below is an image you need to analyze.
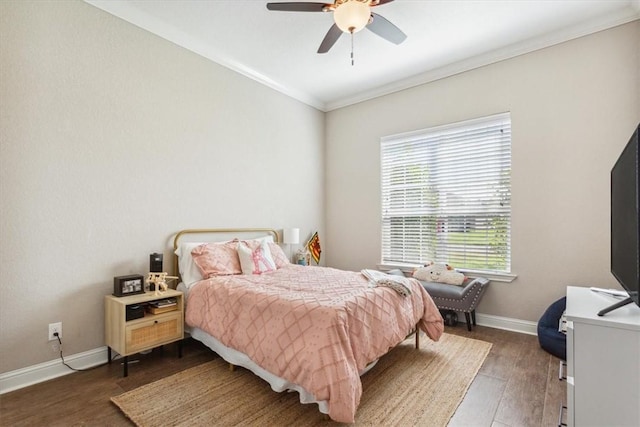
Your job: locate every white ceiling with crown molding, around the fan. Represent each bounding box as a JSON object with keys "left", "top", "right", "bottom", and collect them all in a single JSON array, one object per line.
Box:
[{"left": 85, "top": 0, "right": 640, "bottom": 111}]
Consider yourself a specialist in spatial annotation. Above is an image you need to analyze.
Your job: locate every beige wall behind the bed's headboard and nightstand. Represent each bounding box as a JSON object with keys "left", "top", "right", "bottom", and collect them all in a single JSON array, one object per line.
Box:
[{"left": 0, "top": 1, "right": 325, "bottom": 372}]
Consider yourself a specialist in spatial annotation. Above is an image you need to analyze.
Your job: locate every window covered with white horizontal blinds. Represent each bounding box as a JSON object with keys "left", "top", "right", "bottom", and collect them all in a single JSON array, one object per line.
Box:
[{"left": 381, "top": 113, "right": 511, "bottom": 273}]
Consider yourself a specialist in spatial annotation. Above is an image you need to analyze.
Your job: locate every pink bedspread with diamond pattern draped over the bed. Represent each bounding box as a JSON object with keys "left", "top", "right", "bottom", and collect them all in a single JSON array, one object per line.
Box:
[{"left": 186, "top": 265, "right": 444, "bottom": 423}]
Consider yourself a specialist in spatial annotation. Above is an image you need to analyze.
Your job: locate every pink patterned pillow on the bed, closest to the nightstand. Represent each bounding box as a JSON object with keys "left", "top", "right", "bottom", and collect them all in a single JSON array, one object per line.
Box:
[{"left": 191, "top": 241, "right": 242, "bottom": 279}]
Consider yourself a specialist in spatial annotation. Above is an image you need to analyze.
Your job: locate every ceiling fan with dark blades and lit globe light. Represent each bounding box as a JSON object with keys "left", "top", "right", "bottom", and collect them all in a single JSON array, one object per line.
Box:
[{"left": 267, "top": 0, "right": 407, "bottom": 53}]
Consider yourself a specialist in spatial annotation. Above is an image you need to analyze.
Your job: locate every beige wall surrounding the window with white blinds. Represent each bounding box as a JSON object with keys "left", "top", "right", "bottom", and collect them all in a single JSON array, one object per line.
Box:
[{"left": 325, "top": 21, "right": 640, "bottom": 321}]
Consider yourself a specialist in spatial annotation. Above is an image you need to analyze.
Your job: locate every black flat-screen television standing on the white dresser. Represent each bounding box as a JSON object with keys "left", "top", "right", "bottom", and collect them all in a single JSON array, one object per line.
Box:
[{"left": 598, "top": 124, "right": 640, "bottom": 316}]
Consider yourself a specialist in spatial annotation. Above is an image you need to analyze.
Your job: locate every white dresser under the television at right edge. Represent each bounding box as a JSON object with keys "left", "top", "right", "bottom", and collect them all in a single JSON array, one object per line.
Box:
[{"left": 566, "top": 287, "right": 640, "bottom": 427}]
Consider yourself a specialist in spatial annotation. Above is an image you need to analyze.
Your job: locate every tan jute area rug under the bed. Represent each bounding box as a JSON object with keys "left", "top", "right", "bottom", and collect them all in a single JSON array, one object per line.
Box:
[{"left": 111, "top": 334, "right": 491, "bottom": 427}]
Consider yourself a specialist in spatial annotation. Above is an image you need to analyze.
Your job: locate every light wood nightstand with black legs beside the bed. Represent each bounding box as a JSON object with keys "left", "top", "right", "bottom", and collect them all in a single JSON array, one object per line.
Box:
[{"left": 104, "top": 289, "right": 184, "bottom": 377}]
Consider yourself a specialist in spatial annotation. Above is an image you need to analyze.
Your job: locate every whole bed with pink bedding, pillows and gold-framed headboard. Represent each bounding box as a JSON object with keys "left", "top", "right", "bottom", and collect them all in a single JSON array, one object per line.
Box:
[{"left": 174, "top": 229, "right": 444, "bottom": 423}]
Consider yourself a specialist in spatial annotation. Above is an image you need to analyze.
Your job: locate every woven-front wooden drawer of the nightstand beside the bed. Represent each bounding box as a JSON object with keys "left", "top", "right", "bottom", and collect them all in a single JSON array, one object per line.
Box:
[{"left": 125, "top": 311, "right": 182, "bottom": 354}]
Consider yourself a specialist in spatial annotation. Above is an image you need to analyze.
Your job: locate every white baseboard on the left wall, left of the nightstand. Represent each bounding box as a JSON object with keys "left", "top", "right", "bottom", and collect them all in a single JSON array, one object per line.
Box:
[{"left": 0, "top": 347, "right": 107, "bottom": 394}]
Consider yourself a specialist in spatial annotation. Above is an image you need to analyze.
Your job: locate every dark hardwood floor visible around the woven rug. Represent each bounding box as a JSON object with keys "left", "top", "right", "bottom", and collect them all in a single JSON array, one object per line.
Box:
[{"left": 0, "top": 324, "right": 566, "bottom": 427}]
